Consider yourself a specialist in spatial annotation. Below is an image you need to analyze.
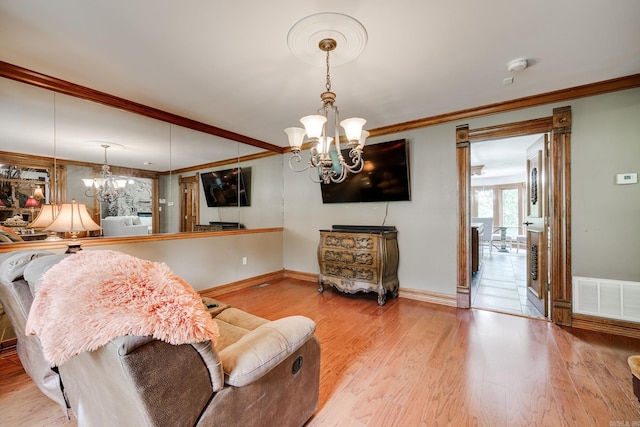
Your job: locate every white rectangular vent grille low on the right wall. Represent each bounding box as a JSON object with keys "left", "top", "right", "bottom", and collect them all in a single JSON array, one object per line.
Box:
[{"left": 573, "top": 276, "right": 640, "bottom": 322}]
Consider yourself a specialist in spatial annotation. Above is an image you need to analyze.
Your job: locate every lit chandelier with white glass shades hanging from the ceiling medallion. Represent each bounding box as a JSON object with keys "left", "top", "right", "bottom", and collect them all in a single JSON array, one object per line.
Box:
[{"left": 284, "top": 38, "right": 369, "bottom": 184}]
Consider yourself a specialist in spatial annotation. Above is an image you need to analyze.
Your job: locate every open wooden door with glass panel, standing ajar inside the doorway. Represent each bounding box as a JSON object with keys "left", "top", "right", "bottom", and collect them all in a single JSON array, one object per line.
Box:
[{"left": 524, "top": 134, "right": 549, "bottom": 317}]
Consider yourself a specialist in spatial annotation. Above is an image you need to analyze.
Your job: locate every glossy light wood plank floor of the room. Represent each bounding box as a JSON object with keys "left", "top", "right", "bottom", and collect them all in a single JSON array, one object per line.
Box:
[{"left": 0, "top": 280, "right": 640, "bottom": 427}]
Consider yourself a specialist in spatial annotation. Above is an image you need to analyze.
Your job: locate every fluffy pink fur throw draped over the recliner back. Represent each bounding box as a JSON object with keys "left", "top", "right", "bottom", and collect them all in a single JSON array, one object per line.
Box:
[{"left": 26, "top": 250, "right": 219, "bottom": 366}]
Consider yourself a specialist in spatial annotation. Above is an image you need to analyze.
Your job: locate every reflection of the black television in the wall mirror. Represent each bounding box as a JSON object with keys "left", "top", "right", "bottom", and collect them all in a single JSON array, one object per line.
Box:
[{"left": 200, "top": 168, "right": 251, "bottom": 208}]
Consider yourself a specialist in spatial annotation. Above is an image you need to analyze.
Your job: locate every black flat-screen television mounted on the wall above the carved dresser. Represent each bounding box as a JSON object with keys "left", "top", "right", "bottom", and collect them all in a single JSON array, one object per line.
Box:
[{"left": 320, "top": 139, "right": 411, "bottom": 203}]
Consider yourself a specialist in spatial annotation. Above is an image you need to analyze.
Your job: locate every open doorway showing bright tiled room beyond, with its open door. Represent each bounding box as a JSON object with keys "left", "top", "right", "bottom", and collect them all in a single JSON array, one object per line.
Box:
[{"left": 470, "top": 134, "right": 549, "bottom": 318}]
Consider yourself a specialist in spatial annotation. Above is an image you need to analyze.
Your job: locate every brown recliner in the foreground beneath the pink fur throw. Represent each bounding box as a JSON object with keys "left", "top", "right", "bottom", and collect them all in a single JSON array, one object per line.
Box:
[{"left": 0, "top": 251, "right": 320, "bottom": 426}]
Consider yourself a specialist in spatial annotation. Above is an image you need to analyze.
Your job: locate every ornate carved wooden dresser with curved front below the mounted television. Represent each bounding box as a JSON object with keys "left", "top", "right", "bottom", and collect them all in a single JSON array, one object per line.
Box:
[{"left": 318, "top": 225, "right": 400, "bottom": 305}]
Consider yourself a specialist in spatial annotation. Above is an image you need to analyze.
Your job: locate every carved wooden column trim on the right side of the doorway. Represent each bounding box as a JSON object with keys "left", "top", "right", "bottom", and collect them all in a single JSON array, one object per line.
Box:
[{"left": 549, "top": 107, "right": 572, "bottom": 326}]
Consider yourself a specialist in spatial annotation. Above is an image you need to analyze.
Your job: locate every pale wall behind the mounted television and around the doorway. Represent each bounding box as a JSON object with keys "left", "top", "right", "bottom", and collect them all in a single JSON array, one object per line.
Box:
[{"left": 283, "top": 89, "right": 640, "bottom": 295}]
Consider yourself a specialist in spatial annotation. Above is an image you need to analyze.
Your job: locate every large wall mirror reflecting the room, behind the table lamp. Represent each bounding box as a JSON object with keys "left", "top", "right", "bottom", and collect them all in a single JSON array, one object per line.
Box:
[{"left": 0, "top": 78, "right": 283, "bottom": 240}]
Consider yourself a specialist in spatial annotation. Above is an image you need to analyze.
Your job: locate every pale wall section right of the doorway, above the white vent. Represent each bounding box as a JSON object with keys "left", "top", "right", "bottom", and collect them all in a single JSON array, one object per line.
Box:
[{"left": 571, "top": 89, "right": 640, "bottom": 282}]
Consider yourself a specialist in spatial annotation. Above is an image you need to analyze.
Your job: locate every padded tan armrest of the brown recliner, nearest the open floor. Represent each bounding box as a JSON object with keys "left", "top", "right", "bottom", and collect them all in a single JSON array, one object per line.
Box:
[{"left": 220, "top": 316, "right": 316, "bottom": 387}]
